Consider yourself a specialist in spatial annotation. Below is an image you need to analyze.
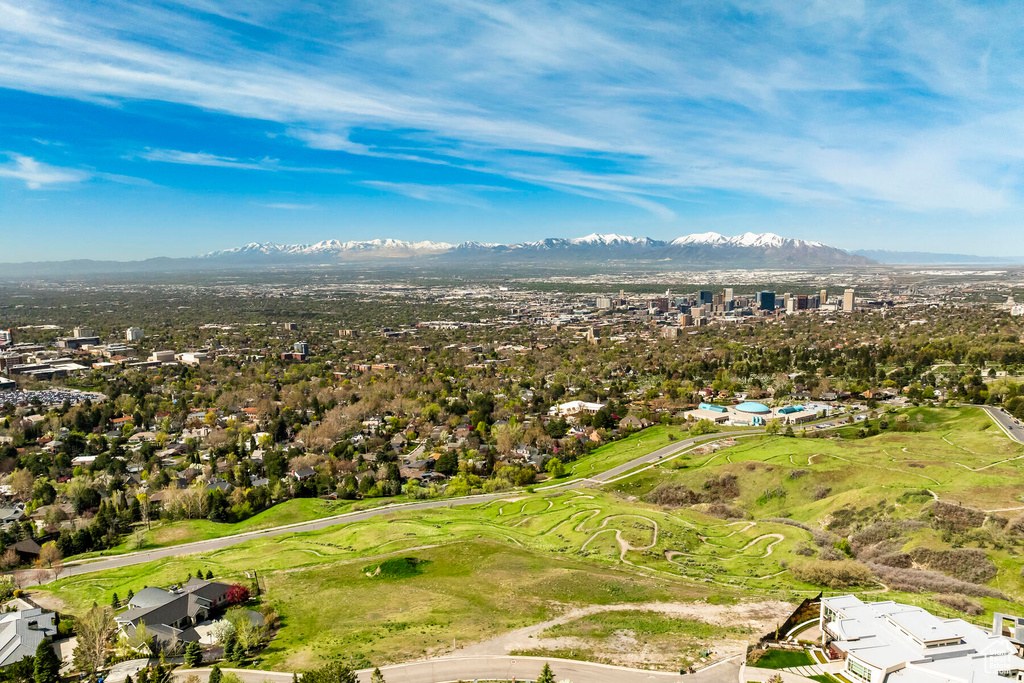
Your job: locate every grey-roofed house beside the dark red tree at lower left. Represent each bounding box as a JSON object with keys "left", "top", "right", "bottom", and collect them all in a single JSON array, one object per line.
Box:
[{"left": 114, "top": 579, "right": 229, "bottom": 649}]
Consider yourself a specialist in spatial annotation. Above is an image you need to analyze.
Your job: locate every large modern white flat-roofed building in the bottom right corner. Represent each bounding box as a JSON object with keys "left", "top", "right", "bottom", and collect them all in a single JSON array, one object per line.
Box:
[{"left": 821, "top": 595, "right": 1024, "bottom": 683}]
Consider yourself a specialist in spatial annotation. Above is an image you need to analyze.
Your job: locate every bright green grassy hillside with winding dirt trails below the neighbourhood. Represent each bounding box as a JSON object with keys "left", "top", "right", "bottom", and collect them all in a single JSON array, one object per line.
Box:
[{"left": 40, "top": 409, "right": 1024, "bottom": 670}]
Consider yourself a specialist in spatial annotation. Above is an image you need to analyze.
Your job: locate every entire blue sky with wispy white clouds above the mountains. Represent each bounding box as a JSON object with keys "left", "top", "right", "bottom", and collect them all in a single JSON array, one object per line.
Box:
[{"left": 0, "top": 0, "right": 1024, "bottom": 262}]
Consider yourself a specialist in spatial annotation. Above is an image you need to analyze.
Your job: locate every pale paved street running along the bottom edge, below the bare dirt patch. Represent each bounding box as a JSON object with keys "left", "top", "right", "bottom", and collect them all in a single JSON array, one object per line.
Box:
[{"left": 174, "top": 656, "right": 740, "bottom": 683}]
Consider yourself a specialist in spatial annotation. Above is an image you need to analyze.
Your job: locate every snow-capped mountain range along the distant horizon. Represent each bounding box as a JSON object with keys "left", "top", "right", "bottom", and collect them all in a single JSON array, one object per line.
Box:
[{"left": 198, "top": 232, "right": 872, "bottom": 267}]
